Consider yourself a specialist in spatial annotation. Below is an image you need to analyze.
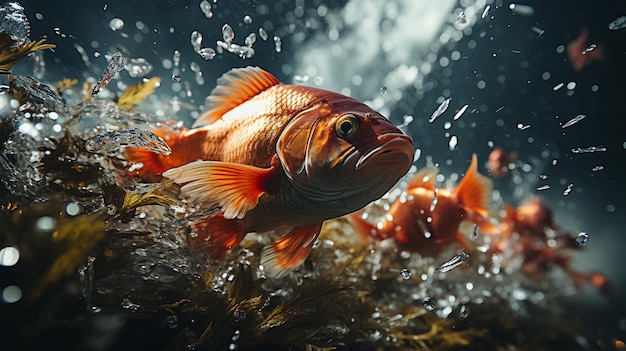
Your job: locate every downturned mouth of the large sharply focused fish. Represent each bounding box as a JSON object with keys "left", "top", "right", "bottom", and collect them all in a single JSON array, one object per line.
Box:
[{"left": 354, "top": 133, "right": 415, "bottom": 171}]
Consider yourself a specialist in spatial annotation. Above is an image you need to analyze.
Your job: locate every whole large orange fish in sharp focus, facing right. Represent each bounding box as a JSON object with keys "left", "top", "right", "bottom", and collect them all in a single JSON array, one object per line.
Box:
[{"left": 126, "top": 67, "right": 414, "bottom": 277}]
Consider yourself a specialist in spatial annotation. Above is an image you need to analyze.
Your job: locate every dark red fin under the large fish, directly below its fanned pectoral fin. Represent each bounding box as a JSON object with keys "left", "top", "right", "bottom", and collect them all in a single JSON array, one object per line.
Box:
[{"left": 195, "top": 214, "right": 247, "bottom": 260}]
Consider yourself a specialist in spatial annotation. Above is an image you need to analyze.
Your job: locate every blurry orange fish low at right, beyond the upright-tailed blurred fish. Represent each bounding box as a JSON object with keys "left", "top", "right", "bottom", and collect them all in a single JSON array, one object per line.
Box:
[{"left": 491, "top": 198, "right": 609, "bottom": 293}]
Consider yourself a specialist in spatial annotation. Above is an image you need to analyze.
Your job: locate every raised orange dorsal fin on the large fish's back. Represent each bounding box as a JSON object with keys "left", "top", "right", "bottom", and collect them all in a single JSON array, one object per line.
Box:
[{"left": 193, "top": 66, "right": 280, "bottom": 127}]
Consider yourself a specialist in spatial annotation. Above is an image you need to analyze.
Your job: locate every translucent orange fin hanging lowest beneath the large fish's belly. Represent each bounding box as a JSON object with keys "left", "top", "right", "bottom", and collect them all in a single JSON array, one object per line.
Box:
[{"left": 261, "top": 223, "right": 322, "bottom": 278}]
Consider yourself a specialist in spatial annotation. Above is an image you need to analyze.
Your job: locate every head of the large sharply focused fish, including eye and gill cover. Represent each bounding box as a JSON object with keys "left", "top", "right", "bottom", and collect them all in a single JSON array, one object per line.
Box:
[{"left": 277, "top": 93, "right": 414, "bottom": 208}]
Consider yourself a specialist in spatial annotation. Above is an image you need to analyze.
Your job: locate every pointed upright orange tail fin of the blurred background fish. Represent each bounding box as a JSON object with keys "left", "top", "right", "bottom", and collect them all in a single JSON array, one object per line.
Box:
[{"left": 453, "top": 154, "right": 493, "bottom": 218}]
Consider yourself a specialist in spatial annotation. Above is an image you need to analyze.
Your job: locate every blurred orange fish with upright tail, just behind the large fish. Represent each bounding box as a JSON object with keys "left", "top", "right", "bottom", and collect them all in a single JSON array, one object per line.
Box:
[{"left": 349, "top": 154, "right": 498, "bottom": 255}]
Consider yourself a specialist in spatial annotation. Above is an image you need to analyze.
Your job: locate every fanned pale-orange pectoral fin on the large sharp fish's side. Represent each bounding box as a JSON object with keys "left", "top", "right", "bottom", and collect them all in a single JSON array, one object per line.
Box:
[{"left": 163, "top": 160, "right": 274, "bottom": 219}]
